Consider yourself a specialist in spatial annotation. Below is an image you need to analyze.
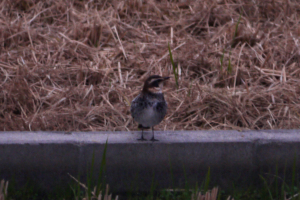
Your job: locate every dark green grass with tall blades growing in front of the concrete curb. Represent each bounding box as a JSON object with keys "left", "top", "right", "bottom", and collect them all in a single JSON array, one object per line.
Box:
[{"left": 0, "top": 142, "right": 300, "bottom": 200}]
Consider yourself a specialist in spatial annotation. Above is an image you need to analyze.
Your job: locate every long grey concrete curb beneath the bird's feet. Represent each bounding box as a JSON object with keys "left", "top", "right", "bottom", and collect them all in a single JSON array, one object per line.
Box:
[{"left": 0, "top": 130, "right": 300, "bottom": 192}]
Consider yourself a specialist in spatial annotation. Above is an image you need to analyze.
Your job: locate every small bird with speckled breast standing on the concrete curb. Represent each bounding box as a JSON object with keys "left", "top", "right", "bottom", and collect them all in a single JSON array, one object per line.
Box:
[{"left": 130, "top": 75, "right": 170, "bottom": 142}]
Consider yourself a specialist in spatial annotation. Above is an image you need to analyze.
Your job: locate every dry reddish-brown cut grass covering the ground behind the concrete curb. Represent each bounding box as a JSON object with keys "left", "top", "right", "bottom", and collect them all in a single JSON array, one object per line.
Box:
[{"left": 0, "top": 0, "right": 300, "bottom": 131}]
